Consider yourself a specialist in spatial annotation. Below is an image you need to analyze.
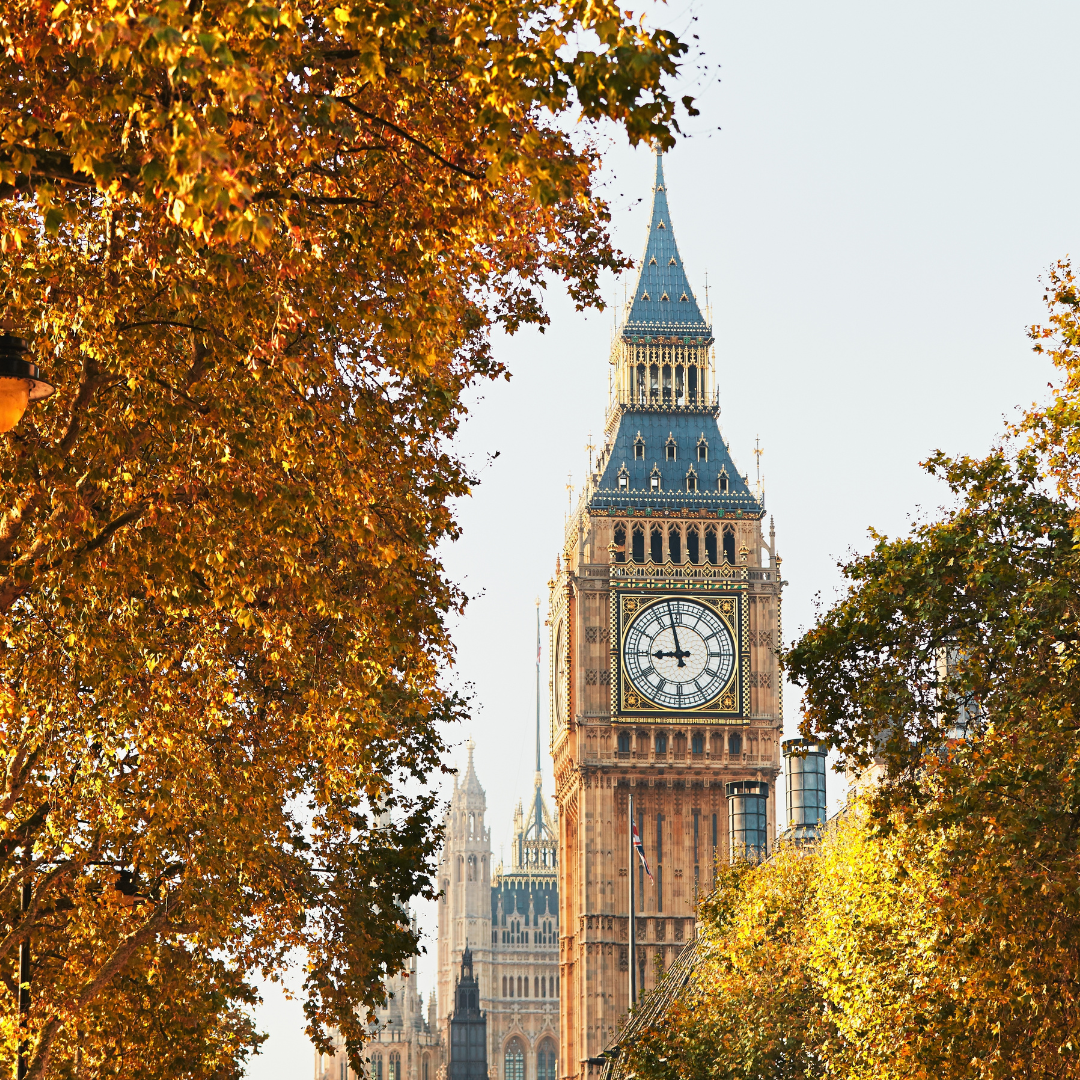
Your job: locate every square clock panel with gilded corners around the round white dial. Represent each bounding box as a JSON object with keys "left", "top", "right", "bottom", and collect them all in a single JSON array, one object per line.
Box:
[{"left": 616, "top": 593, "right": 742, "bottom": 718}]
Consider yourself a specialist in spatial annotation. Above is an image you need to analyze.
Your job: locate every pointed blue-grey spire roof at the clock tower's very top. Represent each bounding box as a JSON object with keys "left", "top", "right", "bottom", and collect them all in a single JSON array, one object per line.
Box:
[{"left": 622, "top": 153, "right": 712, "bottom": 337}]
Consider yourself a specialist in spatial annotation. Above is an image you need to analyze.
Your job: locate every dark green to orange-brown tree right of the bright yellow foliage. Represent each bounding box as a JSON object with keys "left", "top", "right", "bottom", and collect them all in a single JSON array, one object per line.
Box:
[{"left": 788, "top": 257, "right": 1080, "bottom": 1078}]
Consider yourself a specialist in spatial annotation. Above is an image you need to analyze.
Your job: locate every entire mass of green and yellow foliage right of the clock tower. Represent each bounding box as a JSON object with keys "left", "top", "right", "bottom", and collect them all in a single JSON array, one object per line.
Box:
[{"left": 638, "top": 264, "right": 1080, "bottom": 1080}]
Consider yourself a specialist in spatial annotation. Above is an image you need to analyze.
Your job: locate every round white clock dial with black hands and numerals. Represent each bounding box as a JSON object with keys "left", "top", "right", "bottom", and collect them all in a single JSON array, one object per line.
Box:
[{"left": 622, "top": 597, "right": 735, "bottom": 708}]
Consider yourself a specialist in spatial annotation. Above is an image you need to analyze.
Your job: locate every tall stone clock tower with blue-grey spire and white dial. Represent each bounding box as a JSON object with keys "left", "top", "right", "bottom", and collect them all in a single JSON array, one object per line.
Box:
[{"left": 549, "top": 156, "right": 782, "bottom": 1078}]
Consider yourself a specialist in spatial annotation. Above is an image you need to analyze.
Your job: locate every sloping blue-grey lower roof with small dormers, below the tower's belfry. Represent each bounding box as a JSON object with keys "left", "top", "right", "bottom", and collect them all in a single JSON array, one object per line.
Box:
[{"left": 589, "top": 405, "right": 764, "bottom": 517}]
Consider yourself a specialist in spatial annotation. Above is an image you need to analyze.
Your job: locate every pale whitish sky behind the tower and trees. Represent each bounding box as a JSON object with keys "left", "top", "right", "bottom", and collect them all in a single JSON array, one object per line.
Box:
[{"left": 247, "top": 0, "right": 1080, "bottom": 1080}]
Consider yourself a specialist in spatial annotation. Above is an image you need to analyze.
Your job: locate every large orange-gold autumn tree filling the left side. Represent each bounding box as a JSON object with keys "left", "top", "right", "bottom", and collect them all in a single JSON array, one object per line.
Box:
[{"left": 0, "top": 0, "right": 692, "bottom": 1080}]
